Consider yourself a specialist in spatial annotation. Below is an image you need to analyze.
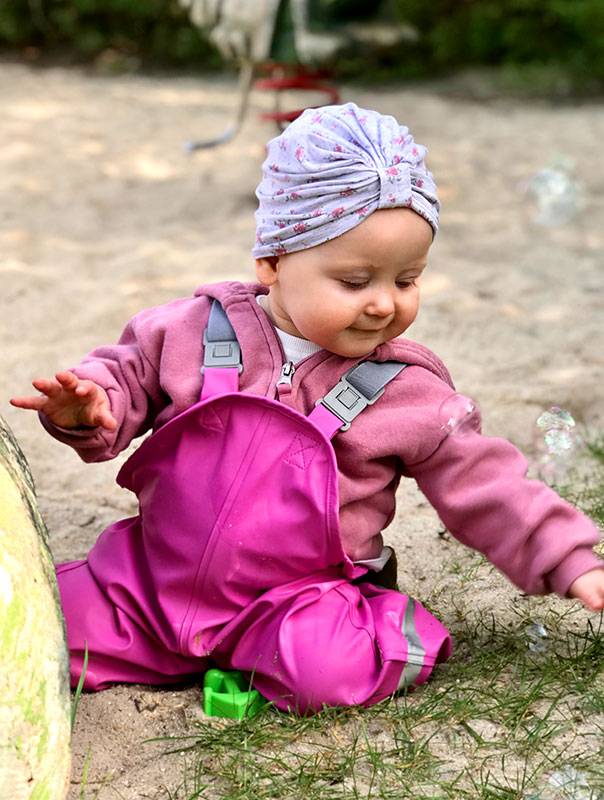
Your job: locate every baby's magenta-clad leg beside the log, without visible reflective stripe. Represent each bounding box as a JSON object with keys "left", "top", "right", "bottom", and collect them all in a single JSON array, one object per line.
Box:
[{"left": 57, "top": 561, "right": 209, "bottom": 690}]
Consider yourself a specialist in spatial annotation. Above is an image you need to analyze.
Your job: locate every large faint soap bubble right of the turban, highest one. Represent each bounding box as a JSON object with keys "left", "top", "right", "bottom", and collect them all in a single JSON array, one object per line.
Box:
[{"left": 525, "top": 158, "right": 585, "bottom": 228}]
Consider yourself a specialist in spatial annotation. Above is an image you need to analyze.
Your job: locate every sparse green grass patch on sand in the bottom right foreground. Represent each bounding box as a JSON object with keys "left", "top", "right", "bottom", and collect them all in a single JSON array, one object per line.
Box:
[{"left": 144, "top": 600, "right": 604, "bottom": 800}]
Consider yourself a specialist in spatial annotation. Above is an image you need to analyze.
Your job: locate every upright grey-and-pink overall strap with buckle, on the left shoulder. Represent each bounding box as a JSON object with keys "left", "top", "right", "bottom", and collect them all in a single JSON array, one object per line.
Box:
[{"left": 201, "top": 300, "right": 243, "bottom": 400}]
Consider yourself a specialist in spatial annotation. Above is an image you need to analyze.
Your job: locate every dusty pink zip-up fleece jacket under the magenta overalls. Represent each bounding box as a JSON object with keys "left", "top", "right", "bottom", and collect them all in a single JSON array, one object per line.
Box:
[{"left": 42, "top": 282, "right": 604, "bottom": 594}]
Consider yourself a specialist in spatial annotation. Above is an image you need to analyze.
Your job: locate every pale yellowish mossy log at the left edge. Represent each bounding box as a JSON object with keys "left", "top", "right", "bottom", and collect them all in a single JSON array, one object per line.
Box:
[{"left": 0, "top": 417, "right": 70, "bottom": 800}]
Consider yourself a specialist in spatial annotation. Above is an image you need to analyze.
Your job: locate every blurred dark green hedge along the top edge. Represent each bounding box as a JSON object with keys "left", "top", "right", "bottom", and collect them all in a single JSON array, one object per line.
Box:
[{"left": 0, "top": 0, "right": 604, "bottom": 96}]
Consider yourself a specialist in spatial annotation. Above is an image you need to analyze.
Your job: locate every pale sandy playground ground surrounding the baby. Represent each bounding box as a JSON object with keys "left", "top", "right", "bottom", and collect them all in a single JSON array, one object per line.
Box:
[{"left": 0, "top": 63, "right": 604, "bottom": 800}]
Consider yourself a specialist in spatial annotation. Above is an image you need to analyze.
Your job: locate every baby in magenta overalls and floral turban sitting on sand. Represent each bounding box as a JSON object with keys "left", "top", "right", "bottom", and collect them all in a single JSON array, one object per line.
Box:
[{"left": 11, "top": 103, "right": 604, "bottom": 712}]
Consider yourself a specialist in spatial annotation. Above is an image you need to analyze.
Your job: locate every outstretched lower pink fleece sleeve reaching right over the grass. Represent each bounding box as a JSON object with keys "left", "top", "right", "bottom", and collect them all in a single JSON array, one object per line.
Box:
[{"left": 406, "top": 432, "right": 604, "bottom": 595}]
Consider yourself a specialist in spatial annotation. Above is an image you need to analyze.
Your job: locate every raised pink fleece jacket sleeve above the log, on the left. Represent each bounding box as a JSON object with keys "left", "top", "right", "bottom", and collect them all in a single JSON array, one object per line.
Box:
[{"left": 40, "top": 298, "right": 208, "bottom": 462}]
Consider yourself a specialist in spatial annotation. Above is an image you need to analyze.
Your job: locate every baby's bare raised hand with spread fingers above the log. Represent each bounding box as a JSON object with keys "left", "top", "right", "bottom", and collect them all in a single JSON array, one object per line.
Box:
[{"left": 10, "top": 372, "right": 117, "bottom": 431}]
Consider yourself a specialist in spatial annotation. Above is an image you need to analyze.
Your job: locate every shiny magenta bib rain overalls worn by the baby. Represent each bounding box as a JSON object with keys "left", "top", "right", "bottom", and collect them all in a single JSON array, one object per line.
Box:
[{"left": 57, "top": 302, "right": 451, "bottom": 713}]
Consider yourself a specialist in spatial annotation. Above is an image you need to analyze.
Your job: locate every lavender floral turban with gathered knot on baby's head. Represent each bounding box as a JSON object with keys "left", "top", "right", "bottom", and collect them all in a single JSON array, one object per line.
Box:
[{"left": 252, "top": 103, "right": 440, "bottom": 258}]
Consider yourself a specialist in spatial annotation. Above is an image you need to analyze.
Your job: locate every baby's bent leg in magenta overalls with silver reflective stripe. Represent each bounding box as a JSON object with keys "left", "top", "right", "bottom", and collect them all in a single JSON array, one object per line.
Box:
[{"left": 219, "top": 579, "right": 451, "bottom": 713}]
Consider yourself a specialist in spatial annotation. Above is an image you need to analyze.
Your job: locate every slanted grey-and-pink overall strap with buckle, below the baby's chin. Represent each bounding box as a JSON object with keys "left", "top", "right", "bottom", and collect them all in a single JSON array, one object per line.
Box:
[{"left": 308, "top": 361, "right": 408, "bottom": 439}]
